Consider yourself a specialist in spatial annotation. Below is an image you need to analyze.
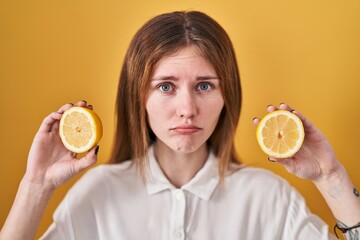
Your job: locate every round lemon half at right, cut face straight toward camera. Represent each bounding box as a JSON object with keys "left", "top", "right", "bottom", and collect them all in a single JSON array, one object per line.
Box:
[{"left": 256, "top": 110, "right": 305, "bottom": 158}]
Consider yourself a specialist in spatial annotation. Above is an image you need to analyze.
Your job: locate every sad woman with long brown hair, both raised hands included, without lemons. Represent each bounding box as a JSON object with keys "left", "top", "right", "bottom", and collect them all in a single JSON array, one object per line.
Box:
[{"left": 1, "top": 12, "right": 360, "bottom": 239}]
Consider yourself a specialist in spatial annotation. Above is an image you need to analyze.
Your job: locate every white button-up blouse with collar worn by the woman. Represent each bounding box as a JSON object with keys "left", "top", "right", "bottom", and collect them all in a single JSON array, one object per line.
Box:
[{"left": 41, "top": 147, "right": 333, "bottom": 240}]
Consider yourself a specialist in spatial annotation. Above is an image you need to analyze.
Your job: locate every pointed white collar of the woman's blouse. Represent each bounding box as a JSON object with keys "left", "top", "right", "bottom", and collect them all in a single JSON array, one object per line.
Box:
[{"left": 146, "top": 146, "right": 219, "bottom": 201}]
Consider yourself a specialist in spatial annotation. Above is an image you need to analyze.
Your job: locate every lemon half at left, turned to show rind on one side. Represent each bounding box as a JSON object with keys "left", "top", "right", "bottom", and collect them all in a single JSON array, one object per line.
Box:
[{"left": 59, "top": 107, "right": 103, "bottom": 153}]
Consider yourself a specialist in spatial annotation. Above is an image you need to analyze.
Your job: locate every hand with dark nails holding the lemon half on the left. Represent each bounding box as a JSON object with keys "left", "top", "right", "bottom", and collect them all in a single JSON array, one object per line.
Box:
[{"left": 23, "top": 101, "right": 97, "bottom": 190}]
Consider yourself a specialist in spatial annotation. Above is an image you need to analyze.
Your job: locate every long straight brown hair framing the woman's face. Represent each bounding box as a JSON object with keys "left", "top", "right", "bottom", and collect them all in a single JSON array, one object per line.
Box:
[{"left": 110, "top": 11, "right": 241, "bottom": 179}]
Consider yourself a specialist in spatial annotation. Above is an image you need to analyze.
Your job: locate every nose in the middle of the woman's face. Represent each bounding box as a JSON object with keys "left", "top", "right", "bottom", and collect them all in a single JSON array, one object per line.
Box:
[{"left": 177, "top": 91, "right": 198, "bottom": 118}]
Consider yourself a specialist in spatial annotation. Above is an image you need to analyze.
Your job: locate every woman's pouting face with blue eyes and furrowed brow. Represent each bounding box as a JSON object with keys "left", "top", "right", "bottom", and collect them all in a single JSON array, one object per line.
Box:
[{"left": 146, "top": 47, "right": 224, "bottom": 153}]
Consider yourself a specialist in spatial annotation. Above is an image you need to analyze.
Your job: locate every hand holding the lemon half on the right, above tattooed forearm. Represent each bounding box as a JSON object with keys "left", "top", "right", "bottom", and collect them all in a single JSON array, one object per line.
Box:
[{"left": 253, "top": 103, "right": 342, "bottom": 182}]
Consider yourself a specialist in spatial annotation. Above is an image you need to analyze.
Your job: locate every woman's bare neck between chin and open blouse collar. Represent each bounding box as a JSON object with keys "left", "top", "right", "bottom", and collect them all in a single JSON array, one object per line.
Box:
[{"left": 155, "top": 140, "right": 209, "bottom": 188}]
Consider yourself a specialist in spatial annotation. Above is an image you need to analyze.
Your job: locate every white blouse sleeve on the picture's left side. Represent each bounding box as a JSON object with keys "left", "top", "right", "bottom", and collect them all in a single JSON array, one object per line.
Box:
[{"left": 40, "top": 166, "right": 106, "bottom": 240}]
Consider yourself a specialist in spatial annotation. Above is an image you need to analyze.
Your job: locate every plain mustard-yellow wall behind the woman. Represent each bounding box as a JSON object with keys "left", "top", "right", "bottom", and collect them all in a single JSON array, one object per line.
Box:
[{"left": 0, "top": 0, "right": 360, "bottom": 234}]
